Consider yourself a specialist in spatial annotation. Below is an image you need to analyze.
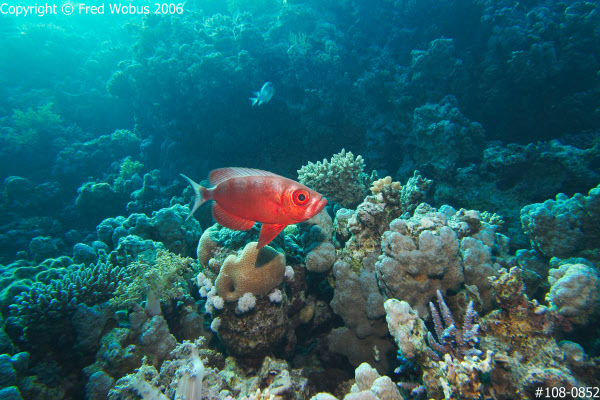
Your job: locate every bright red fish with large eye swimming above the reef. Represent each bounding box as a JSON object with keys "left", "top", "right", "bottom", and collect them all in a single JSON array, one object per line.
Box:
[{"left": 181, "top": 168, "right": 327, "bottom": 249}]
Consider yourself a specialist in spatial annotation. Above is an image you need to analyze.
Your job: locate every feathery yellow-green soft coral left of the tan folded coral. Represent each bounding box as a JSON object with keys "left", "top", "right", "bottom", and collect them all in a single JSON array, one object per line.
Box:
[{"left": 111, "top": 250, "right": 193, "bottom": 315}]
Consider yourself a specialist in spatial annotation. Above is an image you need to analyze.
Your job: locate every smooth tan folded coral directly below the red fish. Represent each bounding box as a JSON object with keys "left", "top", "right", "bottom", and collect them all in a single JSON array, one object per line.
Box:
[{"left": 215, "top": 242, "right": 285, "bottom": 302}]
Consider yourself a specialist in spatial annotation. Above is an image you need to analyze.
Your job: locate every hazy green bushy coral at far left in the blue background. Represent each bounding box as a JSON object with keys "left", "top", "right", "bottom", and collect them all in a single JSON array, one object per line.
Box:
[{"left": 12, "top": 103, "right": 62, "bottom": 145}]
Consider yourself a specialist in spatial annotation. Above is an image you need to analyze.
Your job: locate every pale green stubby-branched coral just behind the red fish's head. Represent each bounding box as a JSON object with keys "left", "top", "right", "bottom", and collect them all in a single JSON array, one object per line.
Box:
[{"left": 298, "top": 149, "right": 369, "bottom": 208}]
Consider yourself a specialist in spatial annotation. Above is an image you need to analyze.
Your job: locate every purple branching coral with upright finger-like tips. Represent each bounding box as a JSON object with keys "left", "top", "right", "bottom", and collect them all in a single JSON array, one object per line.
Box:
[{"left": 427, "top": 290, "right": 481, "bottom": 360}]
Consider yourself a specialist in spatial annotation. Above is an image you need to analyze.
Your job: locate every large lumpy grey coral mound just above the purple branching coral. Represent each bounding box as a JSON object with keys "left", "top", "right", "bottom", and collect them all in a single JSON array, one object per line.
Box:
[{"left": 375, "top": 204, "right": 503, "bottom": 318}]
